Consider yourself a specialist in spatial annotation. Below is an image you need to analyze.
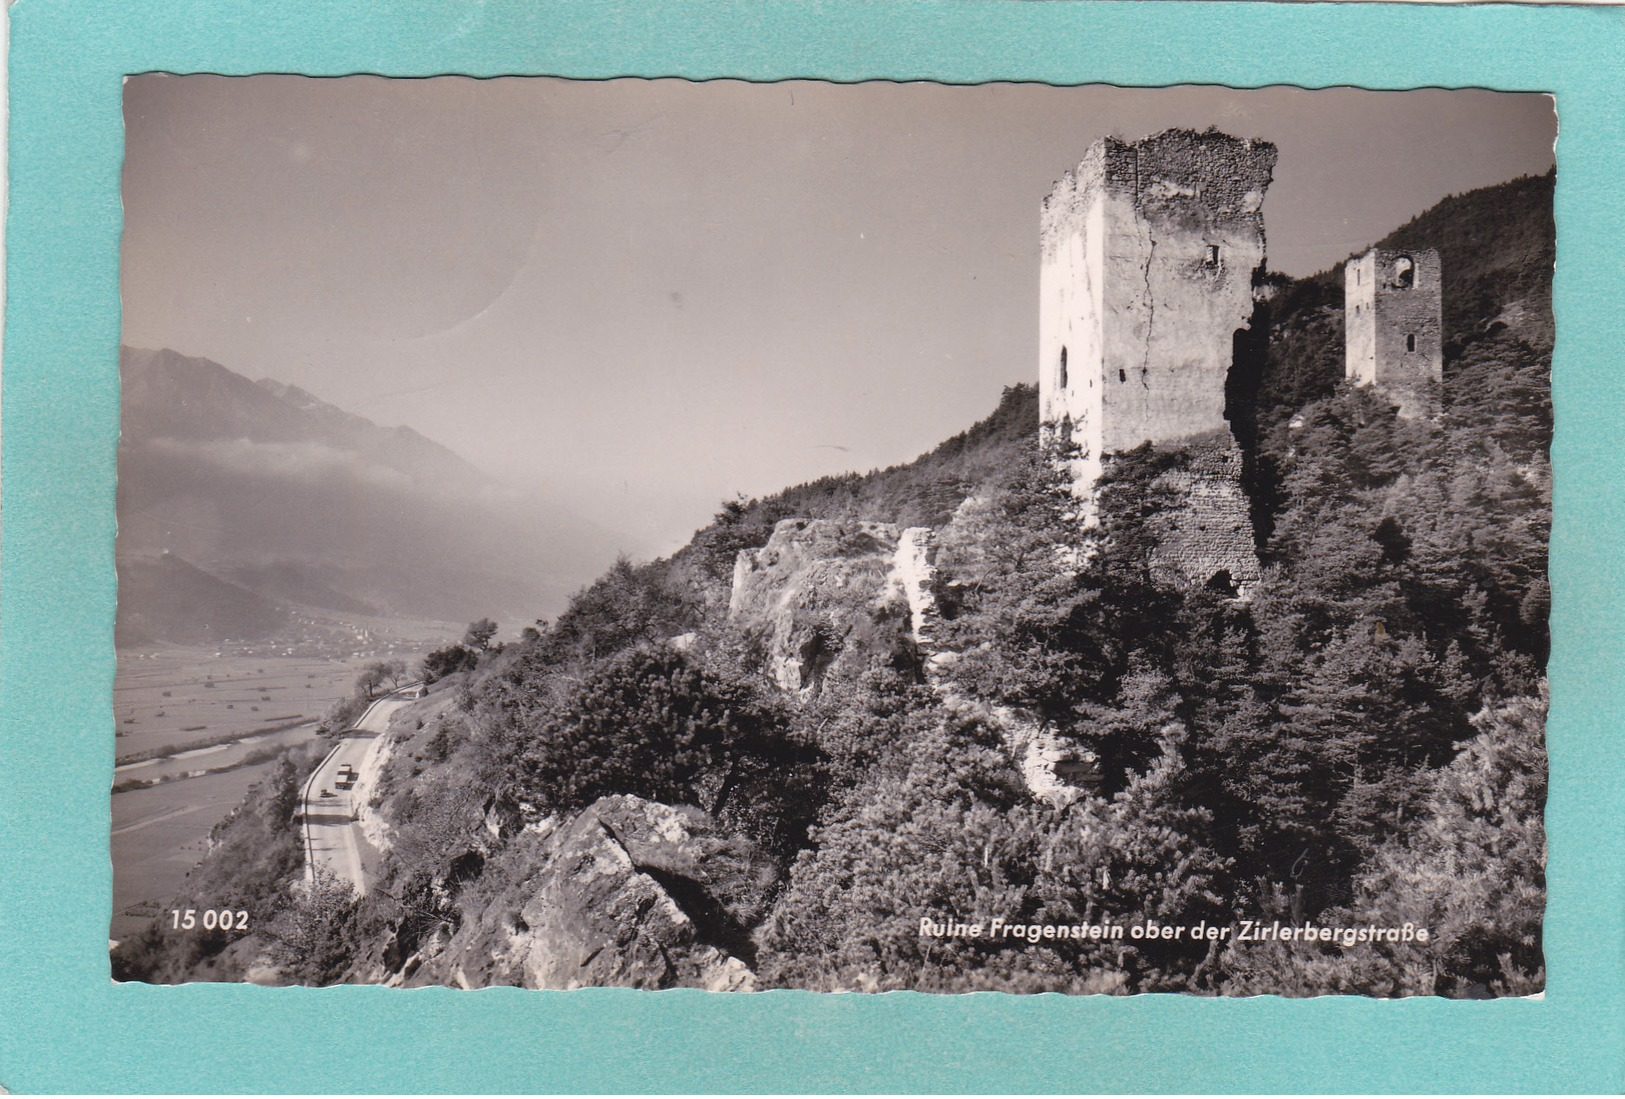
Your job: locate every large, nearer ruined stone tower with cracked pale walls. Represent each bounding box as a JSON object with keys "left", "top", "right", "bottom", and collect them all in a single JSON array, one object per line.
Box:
[{"left": 1038, "top": 130, "right": 1276, "bottom": 592}]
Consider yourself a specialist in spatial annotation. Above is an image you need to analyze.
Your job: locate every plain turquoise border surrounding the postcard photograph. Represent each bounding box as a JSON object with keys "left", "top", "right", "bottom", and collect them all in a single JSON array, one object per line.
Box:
[{"left": 0, "top": 0, "right": 1625, "bottom": 1092}]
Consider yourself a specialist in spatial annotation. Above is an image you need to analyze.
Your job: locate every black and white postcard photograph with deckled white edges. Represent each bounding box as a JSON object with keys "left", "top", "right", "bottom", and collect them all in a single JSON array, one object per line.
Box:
[{"left": 108, "top": 73, "right": 1562, "bottom": 998}]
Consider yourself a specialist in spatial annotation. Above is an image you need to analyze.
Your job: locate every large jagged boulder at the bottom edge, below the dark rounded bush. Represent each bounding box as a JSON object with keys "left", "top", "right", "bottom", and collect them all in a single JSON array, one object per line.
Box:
[{"left": 411, "top": 797, "right": 775, "bottom": 992}]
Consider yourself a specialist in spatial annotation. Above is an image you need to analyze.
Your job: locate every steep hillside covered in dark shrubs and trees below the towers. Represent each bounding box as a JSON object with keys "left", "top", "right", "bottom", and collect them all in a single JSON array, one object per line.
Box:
[{"left": 111, "top": 171, "right": 1552, "bottom": 997}]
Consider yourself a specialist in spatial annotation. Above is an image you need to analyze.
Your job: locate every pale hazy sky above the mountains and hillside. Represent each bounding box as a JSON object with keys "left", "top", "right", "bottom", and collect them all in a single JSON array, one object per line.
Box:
[{"left": 122, "top": 76, "right": 1557, "bottom": 556}]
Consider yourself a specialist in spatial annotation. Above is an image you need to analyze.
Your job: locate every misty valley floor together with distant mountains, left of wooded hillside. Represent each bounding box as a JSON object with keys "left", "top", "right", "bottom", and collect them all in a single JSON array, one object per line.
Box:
[{"left": 112, "top": 348, "right": 630, "bottom": 936}]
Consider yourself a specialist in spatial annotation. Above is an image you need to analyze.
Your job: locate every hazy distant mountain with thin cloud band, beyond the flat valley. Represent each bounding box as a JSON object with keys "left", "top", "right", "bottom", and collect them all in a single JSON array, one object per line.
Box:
[{"left": 119, "top": 348, "right": 616, "bottom": 641}]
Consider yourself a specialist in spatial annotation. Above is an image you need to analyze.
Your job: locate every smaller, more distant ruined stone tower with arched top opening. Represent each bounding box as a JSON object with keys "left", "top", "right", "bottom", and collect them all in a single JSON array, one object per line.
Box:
[{"left": 1342, "top": 249, "right": 1445, "bottom": 419}]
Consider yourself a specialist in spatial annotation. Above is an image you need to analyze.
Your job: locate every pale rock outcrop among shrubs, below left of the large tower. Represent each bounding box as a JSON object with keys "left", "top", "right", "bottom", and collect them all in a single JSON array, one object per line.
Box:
[{"left": 728, "top": 519, "right": 913, "bottom": 693}]
